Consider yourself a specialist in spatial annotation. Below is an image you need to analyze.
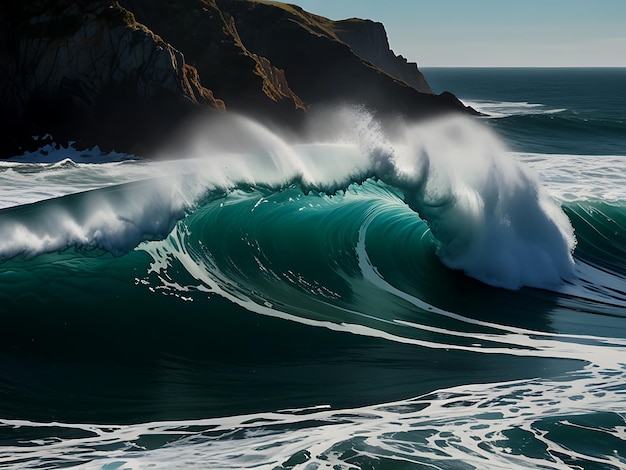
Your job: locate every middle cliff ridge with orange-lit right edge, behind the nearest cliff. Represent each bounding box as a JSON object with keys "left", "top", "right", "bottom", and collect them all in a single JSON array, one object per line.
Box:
[{"left": 120, "top": 0, "right": 304, "bottom": 115}]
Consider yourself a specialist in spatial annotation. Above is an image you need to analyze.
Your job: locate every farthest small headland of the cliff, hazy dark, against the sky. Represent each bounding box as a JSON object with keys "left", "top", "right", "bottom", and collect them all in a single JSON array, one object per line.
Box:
[{"left": 334, "top": 18, "right": 432, "bottom": 93}]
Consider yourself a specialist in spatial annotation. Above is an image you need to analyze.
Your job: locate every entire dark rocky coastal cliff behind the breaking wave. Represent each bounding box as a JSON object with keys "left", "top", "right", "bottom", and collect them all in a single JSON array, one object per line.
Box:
[{"left": 0, "top": 0, "right": 468, "bottom": 156}]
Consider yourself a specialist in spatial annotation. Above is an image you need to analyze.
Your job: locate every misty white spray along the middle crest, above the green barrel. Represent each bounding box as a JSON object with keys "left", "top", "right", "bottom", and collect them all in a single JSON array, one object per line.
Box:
[{"left": 162, "top": 115, "right": 374, "bottom": 194}]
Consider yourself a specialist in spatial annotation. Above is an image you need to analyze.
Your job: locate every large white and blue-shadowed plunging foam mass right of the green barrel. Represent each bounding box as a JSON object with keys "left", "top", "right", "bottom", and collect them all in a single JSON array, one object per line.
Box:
[{"left": 390, "top": 118, "right": 576, "bottom": 289}]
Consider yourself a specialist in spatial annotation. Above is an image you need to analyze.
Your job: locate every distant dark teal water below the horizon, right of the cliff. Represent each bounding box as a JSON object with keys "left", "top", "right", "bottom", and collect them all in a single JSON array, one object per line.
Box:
[{"left": 424, "top": 68, "right": 626, "bottom": 156}]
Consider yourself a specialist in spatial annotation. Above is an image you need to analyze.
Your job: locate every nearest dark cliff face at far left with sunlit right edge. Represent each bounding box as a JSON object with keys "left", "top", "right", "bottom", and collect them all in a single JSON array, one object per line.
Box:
[{"left": 0, "top": 1, "right": 224, "bottom": 154}]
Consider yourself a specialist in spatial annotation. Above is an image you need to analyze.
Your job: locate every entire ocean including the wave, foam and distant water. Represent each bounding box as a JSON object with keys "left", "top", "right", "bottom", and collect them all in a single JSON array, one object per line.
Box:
[{"left": 0, "top": 69, "right": 626, "bottom": 470}]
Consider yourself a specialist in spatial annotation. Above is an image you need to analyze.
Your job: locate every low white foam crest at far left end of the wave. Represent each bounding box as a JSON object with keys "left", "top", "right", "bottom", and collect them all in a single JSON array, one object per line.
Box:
[{"left": 0, "top": 176, "right": 195, "bottom": 259}]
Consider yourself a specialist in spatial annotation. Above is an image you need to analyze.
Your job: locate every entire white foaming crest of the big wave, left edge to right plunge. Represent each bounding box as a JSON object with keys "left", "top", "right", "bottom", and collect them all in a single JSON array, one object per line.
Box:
[{"left": 0, "top": 110, "right": 575, "bottom": 289}]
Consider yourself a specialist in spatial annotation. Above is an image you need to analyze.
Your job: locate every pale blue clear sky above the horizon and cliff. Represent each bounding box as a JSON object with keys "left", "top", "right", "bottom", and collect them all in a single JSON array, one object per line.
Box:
[{"left": 283, "top": 0, "right": 626, "bottom": 67}]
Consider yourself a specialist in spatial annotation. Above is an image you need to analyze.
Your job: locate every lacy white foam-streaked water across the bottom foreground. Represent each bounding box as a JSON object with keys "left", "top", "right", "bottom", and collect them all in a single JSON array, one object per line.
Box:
[{"left": 0, "top": 367, "right": 626, "bottom": 469}]
